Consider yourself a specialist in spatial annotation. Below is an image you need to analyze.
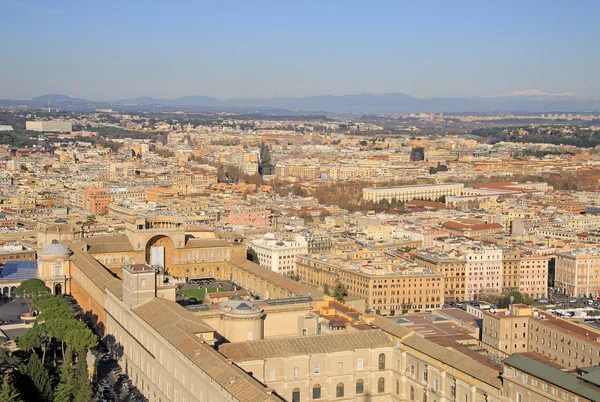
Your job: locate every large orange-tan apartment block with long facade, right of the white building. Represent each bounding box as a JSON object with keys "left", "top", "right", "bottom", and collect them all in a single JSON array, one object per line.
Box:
[{"left": 297, "top": 251, "right": 444, "bottom": 314}]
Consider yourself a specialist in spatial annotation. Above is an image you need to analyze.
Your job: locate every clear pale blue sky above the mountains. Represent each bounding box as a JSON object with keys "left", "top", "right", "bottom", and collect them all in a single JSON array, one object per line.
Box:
[{"left": 0, "top": 0, "right": 600, "bottom": 100}]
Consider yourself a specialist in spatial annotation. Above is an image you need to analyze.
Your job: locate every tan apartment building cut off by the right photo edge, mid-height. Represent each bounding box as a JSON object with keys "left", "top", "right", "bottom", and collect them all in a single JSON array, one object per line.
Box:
[{"left": 554, "top": 247, "right": 600, "bottom": 297}]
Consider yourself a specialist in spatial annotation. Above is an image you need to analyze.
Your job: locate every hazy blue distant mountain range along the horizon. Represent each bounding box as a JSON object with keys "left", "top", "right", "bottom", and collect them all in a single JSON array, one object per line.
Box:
[{"left": 0, "top": 90, "right": 600, "bottom": 114}]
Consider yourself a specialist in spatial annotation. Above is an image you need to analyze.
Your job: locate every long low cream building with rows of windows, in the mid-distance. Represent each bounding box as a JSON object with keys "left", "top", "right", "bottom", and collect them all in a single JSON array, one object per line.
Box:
[{"left": 363, "top": 183, "right": 464, "bottom": 202}]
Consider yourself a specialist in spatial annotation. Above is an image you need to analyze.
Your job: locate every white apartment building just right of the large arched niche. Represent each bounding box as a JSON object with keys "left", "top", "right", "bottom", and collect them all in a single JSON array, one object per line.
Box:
[{"left": 249, "top": 233, "right": 308, "bottom": 276}]
